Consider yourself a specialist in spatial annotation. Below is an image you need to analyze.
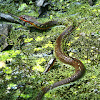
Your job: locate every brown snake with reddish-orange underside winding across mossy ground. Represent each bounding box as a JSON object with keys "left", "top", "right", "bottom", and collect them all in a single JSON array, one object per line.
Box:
[{"left": 19, "top": 15, "right": 86, "bottom": 100}]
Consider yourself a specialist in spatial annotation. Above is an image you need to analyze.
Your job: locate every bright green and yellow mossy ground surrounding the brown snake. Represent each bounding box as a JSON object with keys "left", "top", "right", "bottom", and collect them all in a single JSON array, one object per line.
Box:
[{"left": 0, "top": 0, "right": 100, "bottom": 100}]
